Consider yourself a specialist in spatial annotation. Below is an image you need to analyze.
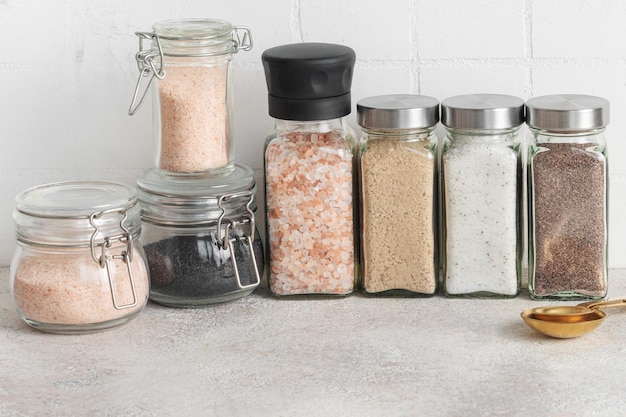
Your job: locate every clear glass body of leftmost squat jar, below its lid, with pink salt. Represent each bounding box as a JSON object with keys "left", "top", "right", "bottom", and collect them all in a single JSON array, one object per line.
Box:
[{"left": 10, "top": 242, "right": 149, "bottom": 333}]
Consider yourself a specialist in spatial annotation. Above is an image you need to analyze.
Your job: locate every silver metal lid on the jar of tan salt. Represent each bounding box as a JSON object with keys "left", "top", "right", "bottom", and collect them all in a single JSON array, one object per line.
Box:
[{"left": 356, "top": 94, "right": 439, "bottom": 129}]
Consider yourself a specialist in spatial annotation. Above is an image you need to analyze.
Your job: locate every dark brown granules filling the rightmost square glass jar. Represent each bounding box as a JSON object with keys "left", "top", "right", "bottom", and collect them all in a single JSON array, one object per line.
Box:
[{"left": 530, "top": 143, "right": 607, "bottom": 297}]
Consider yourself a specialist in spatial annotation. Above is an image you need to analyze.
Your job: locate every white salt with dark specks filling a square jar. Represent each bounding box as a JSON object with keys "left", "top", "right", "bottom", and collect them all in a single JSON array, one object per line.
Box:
[{"left": 443, "top": 140, "right": 520, "bottom": 296}]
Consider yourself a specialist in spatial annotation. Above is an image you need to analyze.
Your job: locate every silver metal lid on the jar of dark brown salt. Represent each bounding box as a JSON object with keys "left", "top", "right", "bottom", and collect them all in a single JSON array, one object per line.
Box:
[{"left": 526, "top": 94, "right": 610, "bottom": 132}]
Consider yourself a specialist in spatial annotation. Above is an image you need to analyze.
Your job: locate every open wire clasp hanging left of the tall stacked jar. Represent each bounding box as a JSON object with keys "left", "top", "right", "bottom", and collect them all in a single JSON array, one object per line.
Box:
[{"left": 128, "top": 32, "right": 165, "bottom": 116}]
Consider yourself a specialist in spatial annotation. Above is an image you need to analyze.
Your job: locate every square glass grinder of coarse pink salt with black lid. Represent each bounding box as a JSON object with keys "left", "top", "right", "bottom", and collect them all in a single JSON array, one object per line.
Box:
[{"left": 262, "top": 43, "right": 358, "bottom": 296}]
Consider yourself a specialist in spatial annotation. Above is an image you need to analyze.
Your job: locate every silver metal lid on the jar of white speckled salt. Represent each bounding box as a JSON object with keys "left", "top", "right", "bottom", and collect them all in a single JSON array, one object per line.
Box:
[{"left": 441, "top": 94, "right": 524, "bottom": 130}]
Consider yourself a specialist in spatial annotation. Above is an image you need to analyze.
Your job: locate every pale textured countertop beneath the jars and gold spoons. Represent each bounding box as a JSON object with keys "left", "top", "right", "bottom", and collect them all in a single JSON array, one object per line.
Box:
[{"left": 0, "top": 268, "right": 626, "bottom": 417}]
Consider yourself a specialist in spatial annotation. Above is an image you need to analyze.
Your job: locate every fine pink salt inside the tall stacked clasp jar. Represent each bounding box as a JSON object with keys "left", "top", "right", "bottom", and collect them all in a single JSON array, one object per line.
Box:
[{"left": 158, "top": 63, "right": 231, "bottom": 172}]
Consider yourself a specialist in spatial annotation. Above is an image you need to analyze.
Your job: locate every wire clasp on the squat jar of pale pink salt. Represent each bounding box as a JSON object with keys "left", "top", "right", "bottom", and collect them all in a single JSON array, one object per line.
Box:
[{"left": 89, "top": 208, "right": 138, "bottom": 310}]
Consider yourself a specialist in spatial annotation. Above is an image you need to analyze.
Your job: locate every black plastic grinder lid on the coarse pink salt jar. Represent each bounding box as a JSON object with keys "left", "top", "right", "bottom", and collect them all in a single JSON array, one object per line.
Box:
[{"left": 261, "top": 43, "right": 356, "bottom": 121}]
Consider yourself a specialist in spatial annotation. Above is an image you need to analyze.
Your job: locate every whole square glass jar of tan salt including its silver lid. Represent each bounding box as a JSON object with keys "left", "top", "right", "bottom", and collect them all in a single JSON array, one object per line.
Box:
[{"left": 357, "top": 94, "right": 439, "bottom": 295}]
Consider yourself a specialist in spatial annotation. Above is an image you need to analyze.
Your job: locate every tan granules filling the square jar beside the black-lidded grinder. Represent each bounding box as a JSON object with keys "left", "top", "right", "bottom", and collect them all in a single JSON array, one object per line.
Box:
[{"left": 361, "top": 137, "right": 437, "bottom": 295}]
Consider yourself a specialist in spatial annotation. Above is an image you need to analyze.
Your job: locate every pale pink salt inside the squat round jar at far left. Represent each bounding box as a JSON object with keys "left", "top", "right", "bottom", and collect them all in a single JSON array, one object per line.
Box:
[{"left": 13, "top": 247, "right": 149, "bottom": 325}]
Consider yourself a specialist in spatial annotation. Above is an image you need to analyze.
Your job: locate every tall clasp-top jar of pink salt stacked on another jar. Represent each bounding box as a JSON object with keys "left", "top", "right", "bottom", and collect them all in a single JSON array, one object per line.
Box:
[{"left": 129, "top": 19, "right": 252, "bottom": 174}]
